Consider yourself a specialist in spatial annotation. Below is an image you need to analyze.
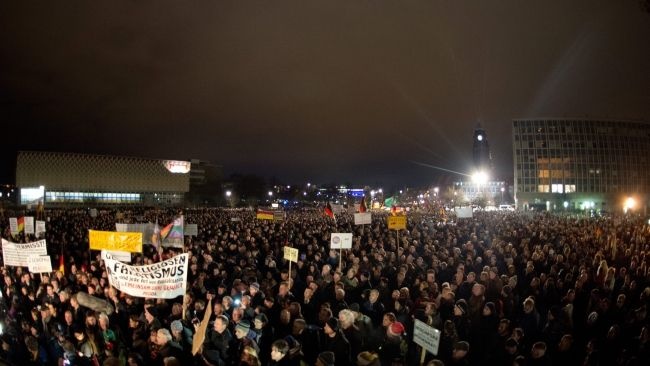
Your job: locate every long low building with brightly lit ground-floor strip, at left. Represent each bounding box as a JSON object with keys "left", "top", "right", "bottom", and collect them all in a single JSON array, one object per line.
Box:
[{"left": 16, "top": 151, "right": 191, "bottom": 206}]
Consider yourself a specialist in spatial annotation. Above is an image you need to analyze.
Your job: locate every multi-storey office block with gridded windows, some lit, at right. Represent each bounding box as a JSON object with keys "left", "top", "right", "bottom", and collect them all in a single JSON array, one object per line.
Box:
[{"left": 512, "top": 119, "right": 650, "bottom": 212}]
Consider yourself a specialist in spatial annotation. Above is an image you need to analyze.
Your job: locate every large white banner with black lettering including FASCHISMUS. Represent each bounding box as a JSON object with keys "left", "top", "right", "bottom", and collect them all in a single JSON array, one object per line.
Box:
[{"left": 104, "top": 253, "right": 189, "bottom": 299}]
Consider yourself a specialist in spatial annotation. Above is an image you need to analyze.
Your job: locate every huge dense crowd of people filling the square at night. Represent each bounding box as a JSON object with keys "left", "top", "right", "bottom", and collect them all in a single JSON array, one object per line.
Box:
[{"left": 0, "top": 209, "right": 650, "bottom": 366}]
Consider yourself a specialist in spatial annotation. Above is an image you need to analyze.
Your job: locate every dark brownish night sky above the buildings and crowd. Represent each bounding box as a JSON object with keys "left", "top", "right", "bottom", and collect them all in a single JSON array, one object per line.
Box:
[{"left": 0, "top": 0, "right": 650, "bottom": 186}]
